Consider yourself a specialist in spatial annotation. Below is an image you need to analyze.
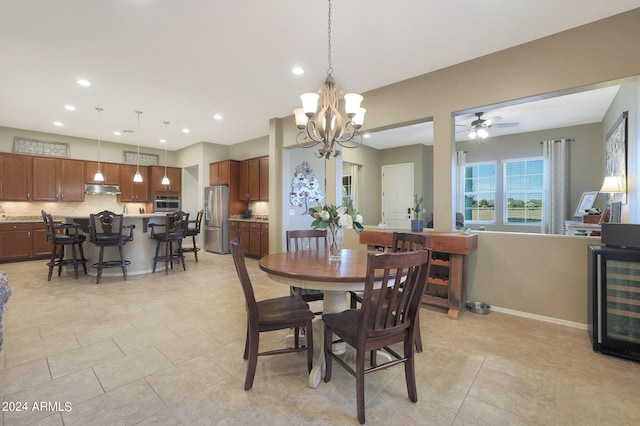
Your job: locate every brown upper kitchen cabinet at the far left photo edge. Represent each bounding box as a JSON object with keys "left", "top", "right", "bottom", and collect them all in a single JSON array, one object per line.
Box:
[{"left": 0, "top": 153, "right": 33, "bottom": 201}]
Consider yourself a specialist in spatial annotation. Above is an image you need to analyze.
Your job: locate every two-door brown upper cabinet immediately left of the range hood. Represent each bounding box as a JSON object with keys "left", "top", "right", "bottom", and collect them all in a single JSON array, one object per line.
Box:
[{"left": 32, "top": 157, "right": 86, "bottom": 201}]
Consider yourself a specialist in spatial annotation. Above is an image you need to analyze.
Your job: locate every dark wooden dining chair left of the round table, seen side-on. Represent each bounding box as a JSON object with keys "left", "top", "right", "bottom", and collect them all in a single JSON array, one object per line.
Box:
[{"left": 231, "top": 238, "right": 314, "bottom": 390}]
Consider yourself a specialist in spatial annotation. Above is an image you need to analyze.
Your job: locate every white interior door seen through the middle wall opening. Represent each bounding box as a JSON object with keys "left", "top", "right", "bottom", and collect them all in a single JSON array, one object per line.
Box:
[{"left": 382, "top": 163, "right": 413, "bottom": 229}]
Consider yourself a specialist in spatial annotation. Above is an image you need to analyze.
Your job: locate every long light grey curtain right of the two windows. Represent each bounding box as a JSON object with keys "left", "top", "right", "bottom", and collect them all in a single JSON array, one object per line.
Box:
[{"left": 541, "top": 139, "right": 570, "bottom": 234}]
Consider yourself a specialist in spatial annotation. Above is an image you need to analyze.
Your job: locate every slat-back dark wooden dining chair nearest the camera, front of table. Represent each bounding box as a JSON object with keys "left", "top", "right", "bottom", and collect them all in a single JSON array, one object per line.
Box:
[{"left": 322, "top": 249, "right": 431, "bottom": 424}]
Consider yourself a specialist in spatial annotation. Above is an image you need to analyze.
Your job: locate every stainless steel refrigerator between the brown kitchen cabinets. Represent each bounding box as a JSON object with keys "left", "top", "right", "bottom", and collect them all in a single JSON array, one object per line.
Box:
[{"left": 204, "top": 185, "right": 229, "bottom": 253}]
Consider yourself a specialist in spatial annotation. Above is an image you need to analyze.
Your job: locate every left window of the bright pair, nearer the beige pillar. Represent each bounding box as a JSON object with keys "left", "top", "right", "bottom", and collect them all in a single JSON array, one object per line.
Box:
[{"left": 464, "top": 162, "right": 496, "bottom": 223}]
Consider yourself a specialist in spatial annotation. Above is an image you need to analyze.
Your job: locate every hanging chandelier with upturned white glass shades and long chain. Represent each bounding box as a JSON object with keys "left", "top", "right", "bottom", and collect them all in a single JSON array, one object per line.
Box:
[{"left": 293, "top": 0, "right": 366, "bottom": 159}]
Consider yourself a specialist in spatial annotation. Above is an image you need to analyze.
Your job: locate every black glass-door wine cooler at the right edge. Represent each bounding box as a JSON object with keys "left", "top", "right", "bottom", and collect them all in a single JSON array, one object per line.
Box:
[{"left": 588, "top": 241, "right": 640, "bottom": 361}]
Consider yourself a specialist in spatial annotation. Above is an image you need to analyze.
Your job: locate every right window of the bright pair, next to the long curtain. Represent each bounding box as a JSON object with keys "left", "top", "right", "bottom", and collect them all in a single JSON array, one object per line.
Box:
[{"left": 504, "top": 158, "right": 544, "bottom": 225}]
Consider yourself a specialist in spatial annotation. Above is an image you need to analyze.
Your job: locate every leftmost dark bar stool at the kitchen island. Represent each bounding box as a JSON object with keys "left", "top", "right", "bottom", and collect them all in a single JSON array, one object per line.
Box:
[{"left": 41, "top": 210, "right": 87, "bottom": 281}]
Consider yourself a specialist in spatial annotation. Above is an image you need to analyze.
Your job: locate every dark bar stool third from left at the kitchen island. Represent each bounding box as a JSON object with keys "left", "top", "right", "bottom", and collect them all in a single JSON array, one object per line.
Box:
[{"left": 148, "top": 211, "right": 189, "bottom": 274}]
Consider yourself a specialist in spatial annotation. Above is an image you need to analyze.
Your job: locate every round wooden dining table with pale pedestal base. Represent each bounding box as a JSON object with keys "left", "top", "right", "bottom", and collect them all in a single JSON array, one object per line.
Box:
[{"left": 260, "top": 249, "right": 380, "bottom": 388}]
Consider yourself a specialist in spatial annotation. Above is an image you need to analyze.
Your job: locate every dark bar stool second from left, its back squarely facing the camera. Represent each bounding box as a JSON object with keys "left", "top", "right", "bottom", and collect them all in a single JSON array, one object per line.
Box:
[{"left": 89, "top": 210, "right": 135, "bottom": 284}]
